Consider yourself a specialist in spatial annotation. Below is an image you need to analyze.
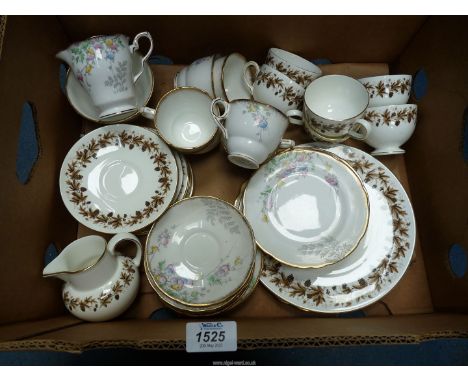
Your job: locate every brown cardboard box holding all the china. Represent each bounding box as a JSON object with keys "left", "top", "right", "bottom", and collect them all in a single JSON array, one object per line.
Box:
[{"left": 0, "top": 16, "right": 468, "bottom": 352}]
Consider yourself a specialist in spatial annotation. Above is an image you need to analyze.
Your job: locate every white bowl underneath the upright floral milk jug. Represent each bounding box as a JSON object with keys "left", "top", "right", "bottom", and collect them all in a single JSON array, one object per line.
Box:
[{"left": 65, "top": 52, "right": 153, "bottom": 123}]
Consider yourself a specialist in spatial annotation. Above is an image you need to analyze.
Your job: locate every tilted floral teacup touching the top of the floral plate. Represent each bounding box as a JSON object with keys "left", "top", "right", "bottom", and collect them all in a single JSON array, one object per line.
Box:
[{"left": 211, "top": 98, "right": 295, "bottom": 169}]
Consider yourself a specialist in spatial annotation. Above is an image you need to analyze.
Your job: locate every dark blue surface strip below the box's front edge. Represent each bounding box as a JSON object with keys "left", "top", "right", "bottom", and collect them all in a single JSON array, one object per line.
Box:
[{"left": 0, "top": 339, "right": 468, "bottom": 366}]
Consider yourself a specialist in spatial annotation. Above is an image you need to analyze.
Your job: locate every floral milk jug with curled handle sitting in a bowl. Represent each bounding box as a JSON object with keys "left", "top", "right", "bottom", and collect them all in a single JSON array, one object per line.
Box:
[{"left": 56, "top": 32, "right": 153, "bottom": 119}]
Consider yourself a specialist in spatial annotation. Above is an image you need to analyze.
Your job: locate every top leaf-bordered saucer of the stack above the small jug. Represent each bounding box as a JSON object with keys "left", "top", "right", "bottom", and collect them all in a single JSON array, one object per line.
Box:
[{"left": 60, "top": 124, "right": 178, "bottom": 233}]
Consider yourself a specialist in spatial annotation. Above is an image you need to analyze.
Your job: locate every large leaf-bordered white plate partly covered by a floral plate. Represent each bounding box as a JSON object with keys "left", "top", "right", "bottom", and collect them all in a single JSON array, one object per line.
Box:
[{"left": 261, "top": 143, "right": 416, "bottom": 313}]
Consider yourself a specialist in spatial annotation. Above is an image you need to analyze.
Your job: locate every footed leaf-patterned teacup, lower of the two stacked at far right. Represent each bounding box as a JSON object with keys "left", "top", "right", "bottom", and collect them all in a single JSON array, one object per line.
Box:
[{"left": 364, "top": 104, "right": 418, "bottom": 156}]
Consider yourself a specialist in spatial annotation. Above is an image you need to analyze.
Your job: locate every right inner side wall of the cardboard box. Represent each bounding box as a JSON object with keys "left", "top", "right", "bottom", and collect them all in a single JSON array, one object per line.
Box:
[{"left": 397, "top": 17, "right": 468, "bottom": 312}]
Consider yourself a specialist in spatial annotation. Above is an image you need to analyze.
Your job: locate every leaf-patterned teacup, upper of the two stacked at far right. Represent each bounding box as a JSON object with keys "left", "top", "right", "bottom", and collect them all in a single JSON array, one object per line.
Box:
[{"left": 359, "top": 74, "right": 412, "bottom": 107}]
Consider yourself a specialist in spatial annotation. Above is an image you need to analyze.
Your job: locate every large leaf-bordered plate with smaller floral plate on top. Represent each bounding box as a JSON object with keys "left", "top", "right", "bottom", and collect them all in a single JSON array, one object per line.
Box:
[{"left": 235, "top": 143, "right": 416, "bottom": 313}]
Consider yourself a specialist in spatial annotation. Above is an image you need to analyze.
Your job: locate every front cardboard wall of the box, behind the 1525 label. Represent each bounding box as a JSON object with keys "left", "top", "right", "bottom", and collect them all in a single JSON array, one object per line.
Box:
[{"left": 0, "top": 314, "right": 468, "bottom": 352}]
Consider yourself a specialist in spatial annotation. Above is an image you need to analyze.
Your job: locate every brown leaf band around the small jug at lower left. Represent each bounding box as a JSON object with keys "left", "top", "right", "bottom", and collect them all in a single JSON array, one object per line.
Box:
[{"left": 63, "top": 259, "right": 136, "bottom": 312}]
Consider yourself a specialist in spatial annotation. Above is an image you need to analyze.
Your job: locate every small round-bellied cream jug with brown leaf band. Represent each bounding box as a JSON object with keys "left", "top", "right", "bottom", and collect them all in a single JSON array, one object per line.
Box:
[{"left": 42, "top": 233, "right": 142, "bottom": 321}]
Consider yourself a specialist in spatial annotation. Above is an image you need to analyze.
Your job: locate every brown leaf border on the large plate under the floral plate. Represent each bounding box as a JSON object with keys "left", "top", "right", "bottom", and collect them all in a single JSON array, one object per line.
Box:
[{"left": 262, "top": 148, "right": 411, "bottom": 308}]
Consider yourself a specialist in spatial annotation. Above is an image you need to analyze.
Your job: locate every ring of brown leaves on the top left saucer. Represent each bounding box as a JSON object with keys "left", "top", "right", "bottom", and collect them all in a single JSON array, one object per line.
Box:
[{"left": 65, "top": 131, "right": 172, "bottom": 229}]
